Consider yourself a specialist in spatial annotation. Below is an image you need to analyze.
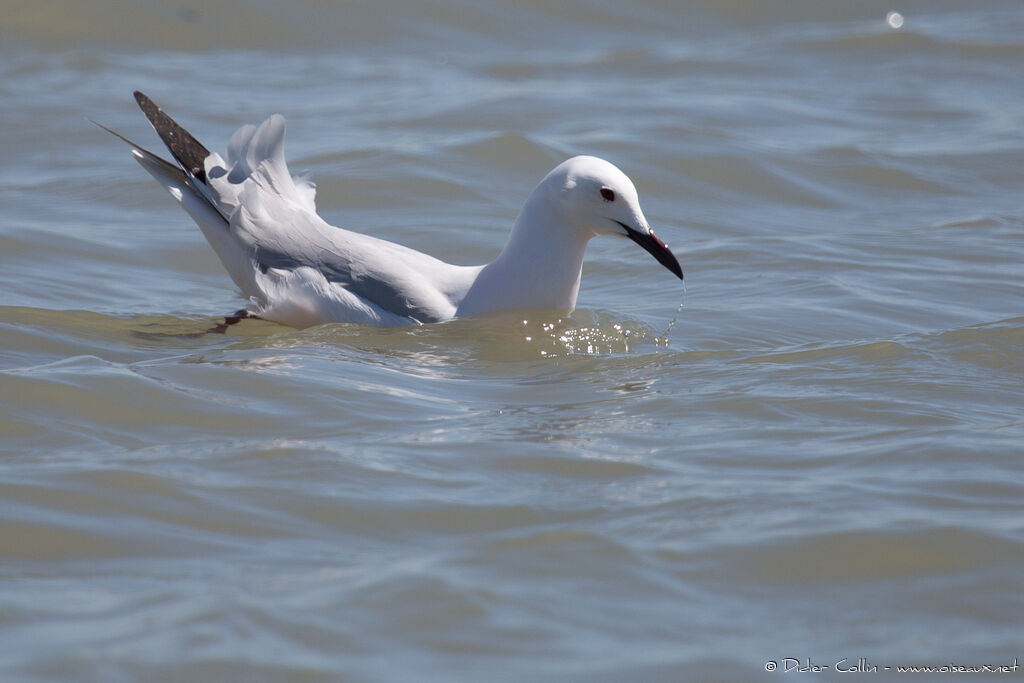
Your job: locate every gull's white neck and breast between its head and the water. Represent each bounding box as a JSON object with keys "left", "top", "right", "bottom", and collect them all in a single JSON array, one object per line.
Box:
[{"left": 458, "top": 188, "right": 589, "bottom": 315}]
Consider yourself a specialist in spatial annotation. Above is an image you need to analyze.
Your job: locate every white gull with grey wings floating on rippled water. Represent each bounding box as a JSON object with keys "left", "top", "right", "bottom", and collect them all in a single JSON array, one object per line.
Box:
[{"left": 97, "top": 91, "right": 683, "bottom": 328}]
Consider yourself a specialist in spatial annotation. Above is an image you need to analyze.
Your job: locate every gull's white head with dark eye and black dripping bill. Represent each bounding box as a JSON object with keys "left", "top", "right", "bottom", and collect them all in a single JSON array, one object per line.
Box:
[{"left": 538, "top": 157, "right": 683, "bottom": 280}]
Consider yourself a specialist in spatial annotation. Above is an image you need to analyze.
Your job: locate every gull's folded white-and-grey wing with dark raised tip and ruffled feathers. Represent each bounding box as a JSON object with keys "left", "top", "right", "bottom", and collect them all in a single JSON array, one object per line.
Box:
[{"left": 128, "top": 91, "right": 463, "bottom": 323}]
